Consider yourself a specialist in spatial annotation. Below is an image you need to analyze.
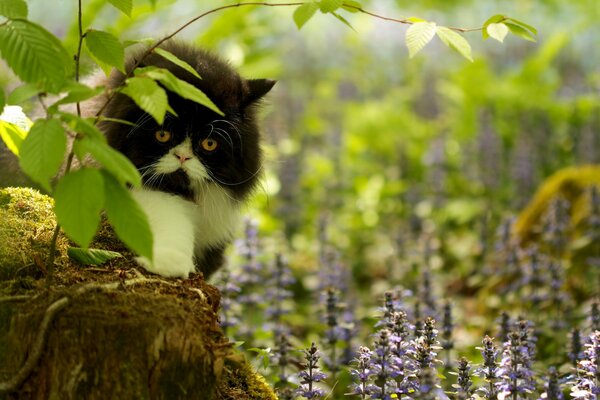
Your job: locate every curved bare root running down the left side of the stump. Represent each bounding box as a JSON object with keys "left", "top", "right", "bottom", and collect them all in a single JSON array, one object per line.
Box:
[{"left": 0, "top": 297, "right": 69, "bottom": 393}]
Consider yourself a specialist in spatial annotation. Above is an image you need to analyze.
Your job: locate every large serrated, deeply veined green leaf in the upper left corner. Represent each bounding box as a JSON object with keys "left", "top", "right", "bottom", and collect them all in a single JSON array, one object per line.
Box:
[{"left": 0, "top": 20, "right": 73, "bottom": 92}]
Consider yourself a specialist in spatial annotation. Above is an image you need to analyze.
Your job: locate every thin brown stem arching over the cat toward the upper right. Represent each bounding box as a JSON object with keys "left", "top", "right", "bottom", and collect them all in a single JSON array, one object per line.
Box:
[{"left": 96, "top": 1, "right": 482, "bottom": 119}]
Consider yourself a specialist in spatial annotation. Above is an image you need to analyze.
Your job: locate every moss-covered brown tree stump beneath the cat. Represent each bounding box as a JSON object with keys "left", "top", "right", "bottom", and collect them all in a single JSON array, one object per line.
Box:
[{"left": 0, "top": 188, "right": 276, "bottom": 400}]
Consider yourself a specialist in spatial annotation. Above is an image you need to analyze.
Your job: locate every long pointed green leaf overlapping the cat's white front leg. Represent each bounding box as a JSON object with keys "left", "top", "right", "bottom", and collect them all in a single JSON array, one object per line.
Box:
[{"left": 102, "top": 171, "right": 152, "bottom": 260}]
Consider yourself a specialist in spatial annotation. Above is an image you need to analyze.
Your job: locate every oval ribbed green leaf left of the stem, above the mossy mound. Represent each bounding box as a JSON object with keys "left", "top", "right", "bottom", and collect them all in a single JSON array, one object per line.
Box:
[{"left": 19, "top": 119, "right": 67, "bottom": 191}]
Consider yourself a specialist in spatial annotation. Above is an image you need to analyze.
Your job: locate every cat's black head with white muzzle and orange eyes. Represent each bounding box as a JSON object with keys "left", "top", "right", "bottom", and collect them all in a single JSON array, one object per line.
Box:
[{"left": 103, "top": 45, "right": 274, "bottom": 200}]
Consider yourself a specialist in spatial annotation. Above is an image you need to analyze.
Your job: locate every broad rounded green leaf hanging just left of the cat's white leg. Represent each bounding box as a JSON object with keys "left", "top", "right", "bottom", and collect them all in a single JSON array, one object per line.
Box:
[{"left": 54, "top": 168, "right": 104, "bottom": 248}]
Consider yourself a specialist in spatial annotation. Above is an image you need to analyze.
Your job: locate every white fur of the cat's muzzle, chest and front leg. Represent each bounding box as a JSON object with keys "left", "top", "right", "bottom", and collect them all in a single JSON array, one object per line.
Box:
[{"left": 132, "top": 139, "right": 240, "bottom": 278}]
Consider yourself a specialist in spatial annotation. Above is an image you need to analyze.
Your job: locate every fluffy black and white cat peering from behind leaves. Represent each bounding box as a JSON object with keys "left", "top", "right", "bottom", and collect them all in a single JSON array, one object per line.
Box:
[{"left": 100, "top": 42, "right": 275, "bottom": 278}]
